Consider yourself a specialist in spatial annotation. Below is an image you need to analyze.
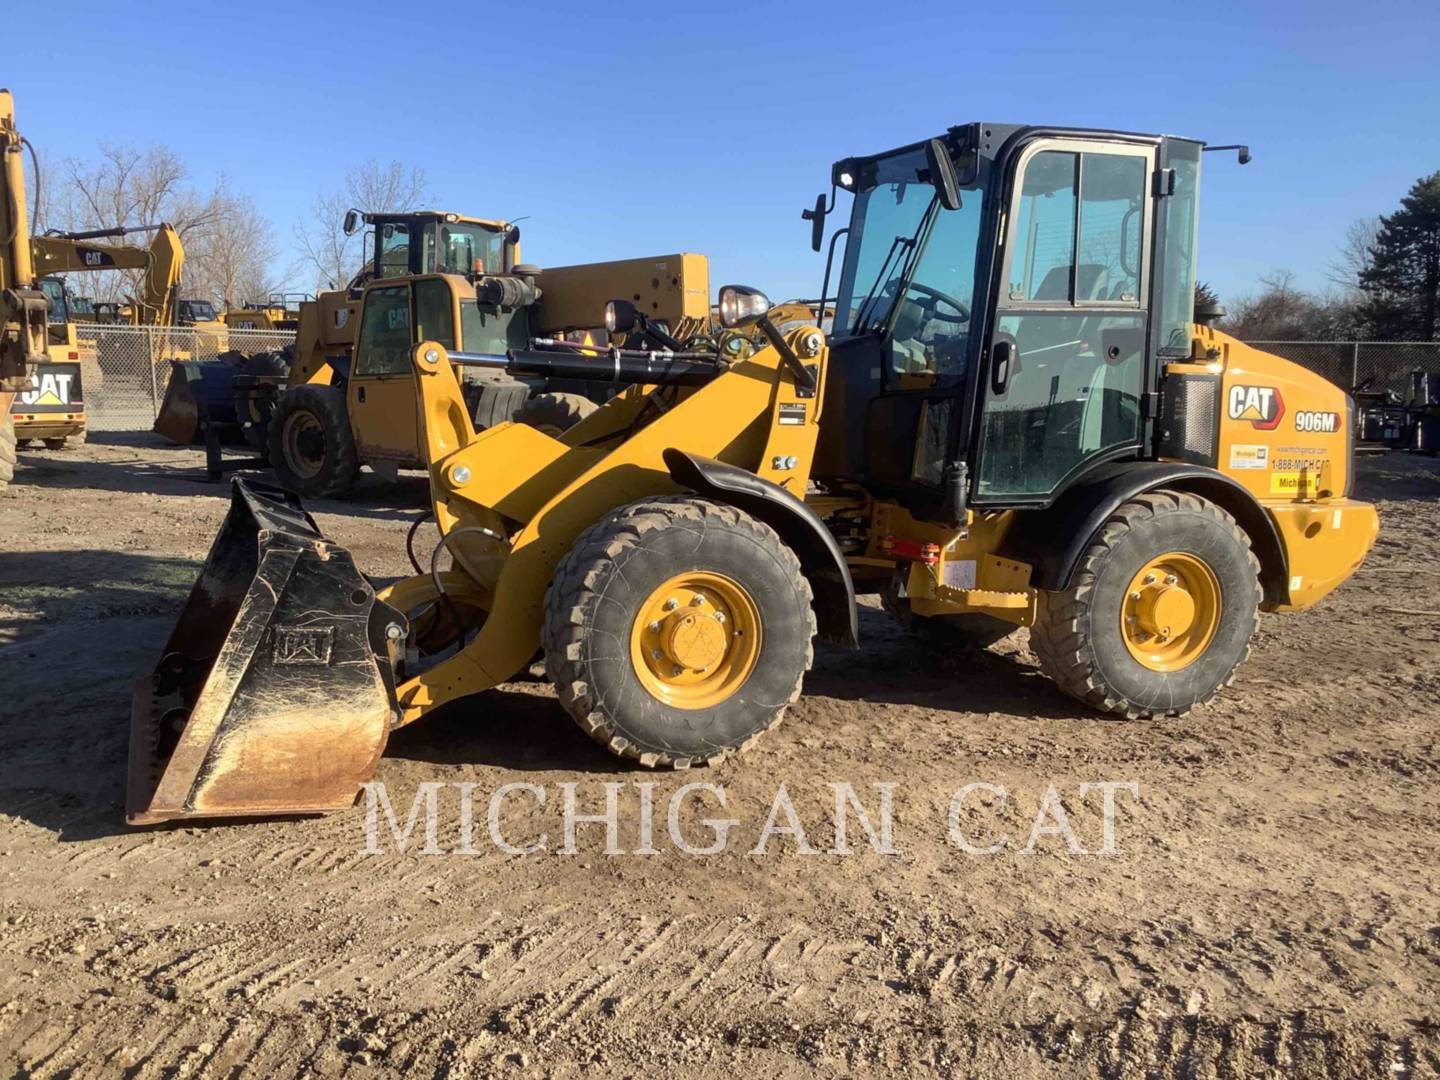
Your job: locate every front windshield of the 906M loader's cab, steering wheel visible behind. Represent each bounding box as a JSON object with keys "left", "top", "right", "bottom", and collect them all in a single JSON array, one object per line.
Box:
[{"left": 835, "top": 150, "right": 984, "bottom": 377}]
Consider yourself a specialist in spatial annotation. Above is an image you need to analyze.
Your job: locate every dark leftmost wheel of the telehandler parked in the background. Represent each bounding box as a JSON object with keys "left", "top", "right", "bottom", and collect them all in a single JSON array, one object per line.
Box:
[{"left": 269, "top": 384, "right": 360, "bottom": 498}]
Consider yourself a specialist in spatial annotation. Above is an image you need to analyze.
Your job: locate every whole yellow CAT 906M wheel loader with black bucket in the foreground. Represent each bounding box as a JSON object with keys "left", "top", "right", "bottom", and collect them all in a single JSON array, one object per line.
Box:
[{"left": 130, "top": 124, "right": 1378, "bottom": 822}]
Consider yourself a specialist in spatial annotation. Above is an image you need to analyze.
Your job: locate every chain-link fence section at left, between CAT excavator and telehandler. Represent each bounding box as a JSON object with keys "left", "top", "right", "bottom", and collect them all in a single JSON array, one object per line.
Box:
[{"left": 70, "top": 323, "right": 295, "bottom": 431}]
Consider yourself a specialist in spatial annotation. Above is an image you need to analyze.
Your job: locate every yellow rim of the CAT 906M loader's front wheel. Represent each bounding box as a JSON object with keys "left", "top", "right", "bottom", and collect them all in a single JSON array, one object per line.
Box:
[{"left": 631, "top": 570, "right": 762, "bottom": 708}]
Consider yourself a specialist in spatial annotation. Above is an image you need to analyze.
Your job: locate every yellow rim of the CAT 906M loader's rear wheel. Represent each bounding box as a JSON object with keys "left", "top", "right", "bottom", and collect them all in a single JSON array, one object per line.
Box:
[{"left": 1120, "top": 552, "right": 1220, "bottom": 671}]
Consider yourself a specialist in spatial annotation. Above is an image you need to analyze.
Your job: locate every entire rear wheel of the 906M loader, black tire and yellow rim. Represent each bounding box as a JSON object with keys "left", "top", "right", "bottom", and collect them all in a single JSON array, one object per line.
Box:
[{"left": 1030, "top": 491, "right": 1261, "bottom": 720}]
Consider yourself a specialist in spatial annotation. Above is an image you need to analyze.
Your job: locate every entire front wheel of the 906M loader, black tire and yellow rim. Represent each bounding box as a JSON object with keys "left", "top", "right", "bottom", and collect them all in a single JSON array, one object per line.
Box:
[{"left": 541, "top": 495, "right": 815, "bottom": 769}]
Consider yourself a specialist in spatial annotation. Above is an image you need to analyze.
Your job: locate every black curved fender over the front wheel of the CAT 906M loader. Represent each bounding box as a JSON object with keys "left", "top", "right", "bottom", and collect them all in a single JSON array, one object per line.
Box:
[{"left": 662, "top": 446, "right": 860, "bottom": 648}]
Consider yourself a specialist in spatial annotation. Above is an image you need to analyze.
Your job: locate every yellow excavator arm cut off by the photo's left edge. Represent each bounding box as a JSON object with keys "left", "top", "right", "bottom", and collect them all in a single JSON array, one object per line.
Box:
[{"left": 0, "top": 89, "right": 49, "bottom": 490}]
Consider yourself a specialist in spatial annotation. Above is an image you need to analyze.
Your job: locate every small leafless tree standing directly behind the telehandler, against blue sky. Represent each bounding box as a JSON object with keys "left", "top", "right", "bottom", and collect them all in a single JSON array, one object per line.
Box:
[{"left": 295, "top": 161, "right": 432, "bottom": 291}]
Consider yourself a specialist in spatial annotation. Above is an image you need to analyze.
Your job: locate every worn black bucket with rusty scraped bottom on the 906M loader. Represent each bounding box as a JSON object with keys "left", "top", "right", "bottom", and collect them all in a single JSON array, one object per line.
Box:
[{"left": 125, "top": 478, "right": 406, "bottom": 825}]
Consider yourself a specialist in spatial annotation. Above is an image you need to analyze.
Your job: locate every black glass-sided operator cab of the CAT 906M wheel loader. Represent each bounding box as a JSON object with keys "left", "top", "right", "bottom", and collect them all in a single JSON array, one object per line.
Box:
[{"left": 816, "top": 124, "right": 1201, "bottom": 520}]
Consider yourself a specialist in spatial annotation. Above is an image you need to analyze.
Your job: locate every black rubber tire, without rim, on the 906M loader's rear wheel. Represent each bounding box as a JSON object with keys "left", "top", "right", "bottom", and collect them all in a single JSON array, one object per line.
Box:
[{"left": 1030, "top": 491, "right": 1263, "bottom": 720}]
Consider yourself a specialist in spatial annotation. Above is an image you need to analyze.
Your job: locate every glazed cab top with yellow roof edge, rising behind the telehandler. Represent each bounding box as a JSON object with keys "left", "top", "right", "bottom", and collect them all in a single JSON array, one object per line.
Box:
[{"left": 364, "top": 210, "right": 520, "bottom": 278}]
